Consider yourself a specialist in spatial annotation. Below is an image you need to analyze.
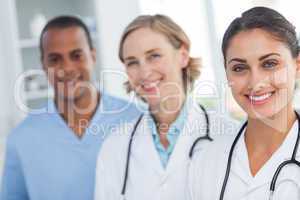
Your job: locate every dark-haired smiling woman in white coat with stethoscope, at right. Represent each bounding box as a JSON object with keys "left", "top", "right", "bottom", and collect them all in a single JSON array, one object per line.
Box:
[{"left": 189, "top": 7, "right": 300, "bottom": 200}]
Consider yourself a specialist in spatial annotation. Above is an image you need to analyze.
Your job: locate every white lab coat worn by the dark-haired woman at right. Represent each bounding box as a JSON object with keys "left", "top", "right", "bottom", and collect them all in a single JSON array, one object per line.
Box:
[{"left": 188, "top": 121, "right": 300, "bottom": 200}]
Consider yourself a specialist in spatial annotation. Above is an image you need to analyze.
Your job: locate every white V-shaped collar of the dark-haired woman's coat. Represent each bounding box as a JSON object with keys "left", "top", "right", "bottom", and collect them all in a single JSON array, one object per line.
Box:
[{"left": 231, "top": 121, "right": 299, "bottom": 192}]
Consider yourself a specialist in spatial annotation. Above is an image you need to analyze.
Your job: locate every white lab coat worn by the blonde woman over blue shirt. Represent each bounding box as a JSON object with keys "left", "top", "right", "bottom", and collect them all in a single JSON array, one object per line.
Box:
[{"left": 95, "top": 103, "right": 237, "bottom": 200}]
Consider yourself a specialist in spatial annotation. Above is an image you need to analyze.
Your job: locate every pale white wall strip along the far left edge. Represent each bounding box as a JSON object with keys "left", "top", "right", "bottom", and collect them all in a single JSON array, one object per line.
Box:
[{"left": 0, "top": 0, "right": 21, "bottom": 177}]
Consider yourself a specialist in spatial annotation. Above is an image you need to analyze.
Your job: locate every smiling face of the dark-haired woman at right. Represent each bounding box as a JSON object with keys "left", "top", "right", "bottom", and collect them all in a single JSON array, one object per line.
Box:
[{"left": 226, "top": 29, "right": 300, "bottom": 118}]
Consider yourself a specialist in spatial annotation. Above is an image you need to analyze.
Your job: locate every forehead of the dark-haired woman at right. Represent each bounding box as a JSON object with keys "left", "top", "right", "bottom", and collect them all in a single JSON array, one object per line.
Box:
[{"left": 226, "top": 29, "right": 290, "bottom": 60}]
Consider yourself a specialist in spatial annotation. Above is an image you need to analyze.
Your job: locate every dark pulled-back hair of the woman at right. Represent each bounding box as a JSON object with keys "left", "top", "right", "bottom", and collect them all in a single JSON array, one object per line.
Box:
[{"left": 222, "top": 7, "right": 299, "bottom": 65}]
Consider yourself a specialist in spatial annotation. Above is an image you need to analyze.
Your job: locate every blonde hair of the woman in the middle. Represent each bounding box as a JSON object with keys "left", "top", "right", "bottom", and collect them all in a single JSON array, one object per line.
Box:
[{"left": 119, "top": 14, "right": 201, "bottom": 92}]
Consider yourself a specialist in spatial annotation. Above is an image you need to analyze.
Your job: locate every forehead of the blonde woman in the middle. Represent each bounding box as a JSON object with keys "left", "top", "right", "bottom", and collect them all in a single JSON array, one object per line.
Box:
[{"left": 122, "top": 28, "right": 172, "bottom": 58}]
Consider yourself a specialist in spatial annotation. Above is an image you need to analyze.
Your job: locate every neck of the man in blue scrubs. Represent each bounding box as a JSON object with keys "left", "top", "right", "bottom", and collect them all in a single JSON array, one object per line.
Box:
[{"left": 55, "top": 87, "right": 100, "bottom": 126}]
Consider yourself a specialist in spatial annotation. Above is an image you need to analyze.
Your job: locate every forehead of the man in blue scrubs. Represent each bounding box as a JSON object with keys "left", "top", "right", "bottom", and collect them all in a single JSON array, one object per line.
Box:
[{"left": 42, "top": 26, "right": 89, "bottom": 53}]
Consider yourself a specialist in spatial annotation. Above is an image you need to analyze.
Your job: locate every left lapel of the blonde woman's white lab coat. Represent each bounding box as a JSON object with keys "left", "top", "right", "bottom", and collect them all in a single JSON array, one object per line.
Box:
[{"left": 132, "top": 115, "right": 164, "bottom": 175}]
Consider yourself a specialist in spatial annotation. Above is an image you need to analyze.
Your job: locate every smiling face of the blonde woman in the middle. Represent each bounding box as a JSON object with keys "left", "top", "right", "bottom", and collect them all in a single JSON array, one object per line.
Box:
[{"left": 123, "top": 28, "right": 189, "bottom": 108}]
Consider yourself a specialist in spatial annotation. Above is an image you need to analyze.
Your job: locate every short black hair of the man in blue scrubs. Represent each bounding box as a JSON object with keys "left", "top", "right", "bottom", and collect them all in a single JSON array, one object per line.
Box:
[{"left": 39, "top": 15, "right": 94, "bottom": 56}]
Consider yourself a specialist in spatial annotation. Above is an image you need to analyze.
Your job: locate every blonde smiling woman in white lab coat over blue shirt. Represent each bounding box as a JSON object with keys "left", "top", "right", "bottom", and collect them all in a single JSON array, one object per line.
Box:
[{"left": 95, "top": 15, "right": 237, "bottom": 200}]
